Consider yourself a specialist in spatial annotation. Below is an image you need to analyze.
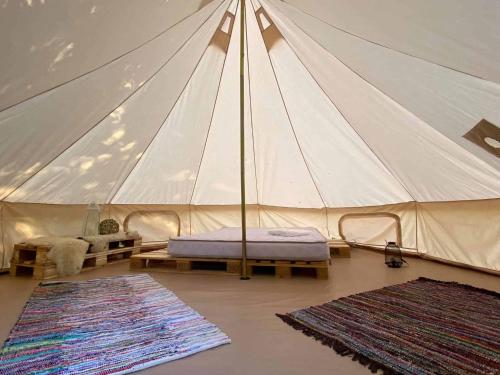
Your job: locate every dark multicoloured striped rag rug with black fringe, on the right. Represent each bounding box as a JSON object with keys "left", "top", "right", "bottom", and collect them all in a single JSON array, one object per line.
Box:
[{"left": 278, "top": 278, "right": 500, "bottom": 375}]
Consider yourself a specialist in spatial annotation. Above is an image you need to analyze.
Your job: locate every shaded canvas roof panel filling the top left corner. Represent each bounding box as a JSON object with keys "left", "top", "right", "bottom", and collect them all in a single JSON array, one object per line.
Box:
[{"left": 0, "top": 0, "right": 215, "bottom": 110}]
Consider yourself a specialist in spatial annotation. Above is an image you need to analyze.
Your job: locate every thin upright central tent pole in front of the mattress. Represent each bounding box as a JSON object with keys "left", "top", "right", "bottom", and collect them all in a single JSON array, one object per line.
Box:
[{"left": 240, "top": 0, "right": 249, "bottom": 280}]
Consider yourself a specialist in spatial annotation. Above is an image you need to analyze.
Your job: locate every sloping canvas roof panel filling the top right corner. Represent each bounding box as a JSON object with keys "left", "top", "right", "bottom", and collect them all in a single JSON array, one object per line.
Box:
[{"left": 280, "top": 0, "right": 500, "bottom": 83}]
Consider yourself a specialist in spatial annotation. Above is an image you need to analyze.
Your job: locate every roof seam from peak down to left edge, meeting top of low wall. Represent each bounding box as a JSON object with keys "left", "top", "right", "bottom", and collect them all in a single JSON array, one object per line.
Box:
[{"left": 0, "top": 0, "right": 226, "bottom": 201}]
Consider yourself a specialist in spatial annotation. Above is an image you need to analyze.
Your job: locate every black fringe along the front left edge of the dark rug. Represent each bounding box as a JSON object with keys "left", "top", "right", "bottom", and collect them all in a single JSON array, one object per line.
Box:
[{"left": 276, "top": 314, "right": 398, "bottom": 375}]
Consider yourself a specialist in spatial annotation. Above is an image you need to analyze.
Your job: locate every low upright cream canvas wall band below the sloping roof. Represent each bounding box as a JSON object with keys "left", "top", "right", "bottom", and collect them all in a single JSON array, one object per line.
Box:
[{"left": 0, "top": 200, "right": 500, "bottom": 271}]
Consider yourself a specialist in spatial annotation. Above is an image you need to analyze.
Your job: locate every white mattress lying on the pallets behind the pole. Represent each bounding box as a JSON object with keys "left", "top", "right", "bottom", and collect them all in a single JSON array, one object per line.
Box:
[{"left": 168, "top": 228, "right": 330, "bottom": 261}]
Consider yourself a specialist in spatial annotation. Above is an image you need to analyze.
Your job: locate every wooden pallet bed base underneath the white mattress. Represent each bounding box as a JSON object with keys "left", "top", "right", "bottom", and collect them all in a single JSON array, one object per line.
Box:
[{"left": 130, "top": 250, "right": 328, "bottom": 279}]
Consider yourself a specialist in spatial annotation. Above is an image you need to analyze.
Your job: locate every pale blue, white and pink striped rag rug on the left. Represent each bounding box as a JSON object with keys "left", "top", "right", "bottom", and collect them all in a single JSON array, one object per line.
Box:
[{"left": 0, "top": 274, "right": 230, "bottom": 375}]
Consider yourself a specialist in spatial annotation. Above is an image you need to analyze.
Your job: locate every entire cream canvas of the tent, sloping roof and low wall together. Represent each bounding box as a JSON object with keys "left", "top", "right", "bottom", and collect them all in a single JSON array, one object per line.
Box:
[{"left": 0, "top": 0, "right": 500, "bottom": 270}]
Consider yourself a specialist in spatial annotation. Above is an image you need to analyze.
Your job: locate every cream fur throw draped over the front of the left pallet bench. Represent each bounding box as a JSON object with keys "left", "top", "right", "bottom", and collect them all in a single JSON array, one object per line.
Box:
[{"left": 26, "top": 237, "right": 89, "bottom": 276}]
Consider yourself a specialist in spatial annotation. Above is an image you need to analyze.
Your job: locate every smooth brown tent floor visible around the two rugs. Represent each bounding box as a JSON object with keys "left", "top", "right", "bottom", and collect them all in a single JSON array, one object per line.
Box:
[{"left": 0, "top": 249, "right": 500, "bottom": 375}]
